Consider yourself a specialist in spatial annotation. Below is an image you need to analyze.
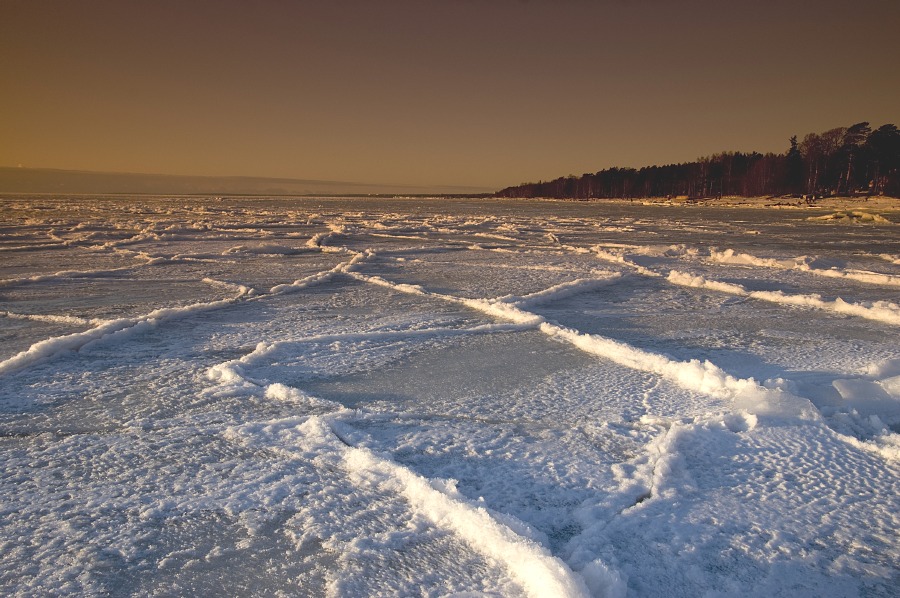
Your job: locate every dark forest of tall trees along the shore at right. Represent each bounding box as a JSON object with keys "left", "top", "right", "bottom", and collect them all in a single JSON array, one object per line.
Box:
[{"left": 495, "top": 122, "right": 900, "bottom": 199}]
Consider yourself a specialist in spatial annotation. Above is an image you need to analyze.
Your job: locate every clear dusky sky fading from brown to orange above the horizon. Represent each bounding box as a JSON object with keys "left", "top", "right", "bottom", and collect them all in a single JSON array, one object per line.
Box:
[{"left": 0, "top": 0, "right": 900, "bottom": 189}]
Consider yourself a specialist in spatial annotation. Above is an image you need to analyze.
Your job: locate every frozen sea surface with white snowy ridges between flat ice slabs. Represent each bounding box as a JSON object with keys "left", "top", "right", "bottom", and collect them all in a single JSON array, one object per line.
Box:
[{"left": 0, "top": 196, "right": 900, "bottom": 598}]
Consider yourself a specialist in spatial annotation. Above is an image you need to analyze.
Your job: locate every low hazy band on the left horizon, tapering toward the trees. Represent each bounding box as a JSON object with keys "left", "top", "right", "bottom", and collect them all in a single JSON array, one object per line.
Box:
[{"left": 0, "top": 166, "right": 494, "bottom": 195}]
